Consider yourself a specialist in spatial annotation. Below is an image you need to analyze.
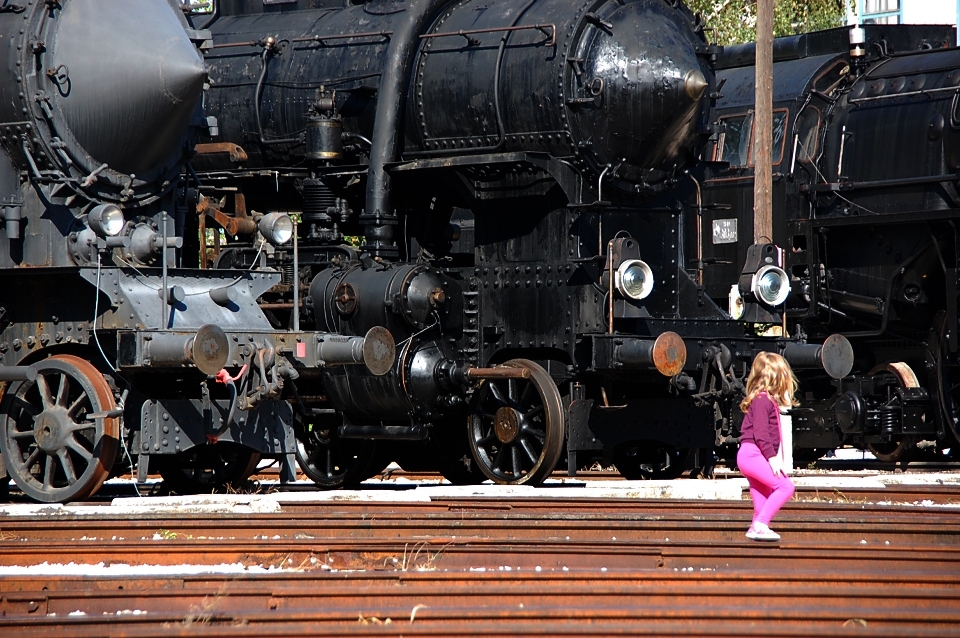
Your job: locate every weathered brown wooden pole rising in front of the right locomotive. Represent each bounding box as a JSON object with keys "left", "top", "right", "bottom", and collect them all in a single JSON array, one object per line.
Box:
[{"left": 753, "top": 0, "right": 774, "bottom": 244}]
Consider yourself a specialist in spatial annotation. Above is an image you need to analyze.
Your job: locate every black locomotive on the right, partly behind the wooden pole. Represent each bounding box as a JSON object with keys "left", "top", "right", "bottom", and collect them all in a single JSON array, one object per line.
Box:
[{"left": 699, "top": 25, "right": 960, "bottom": 462}]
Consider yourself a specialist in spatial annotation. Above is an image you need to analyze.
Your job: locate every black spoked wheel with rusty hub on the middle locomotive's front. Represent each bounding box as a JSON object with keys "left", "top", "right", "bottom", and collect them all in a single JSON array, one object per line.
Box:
[{"left": 468, "top": 359, "right": 564, "bottom": 485}]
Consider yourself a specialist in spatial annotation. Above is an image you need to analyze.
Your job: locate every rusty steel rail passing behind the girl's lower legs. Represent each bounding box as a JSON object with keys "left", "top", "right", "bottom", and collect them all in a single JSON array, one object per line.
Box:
[{"left": 0, "top": 502, "right": 960, "bottom": 547}]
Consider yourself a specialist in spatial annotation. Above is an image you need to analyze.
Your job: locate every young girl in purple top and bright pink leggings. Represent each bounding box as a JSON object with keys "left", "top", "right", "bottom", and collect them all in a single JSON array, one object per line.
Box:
[{"left": 737, "top": 352, "right": 798, "bottom": 541}]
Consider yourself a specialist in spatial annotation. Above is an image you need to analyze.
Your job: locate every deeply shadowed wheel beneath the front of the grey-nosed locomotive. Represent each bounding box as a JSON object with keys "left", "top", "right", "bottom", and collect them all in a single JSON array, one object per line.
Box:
[{"left": 158, "top": 441, "right": 260, "bottom": 494}]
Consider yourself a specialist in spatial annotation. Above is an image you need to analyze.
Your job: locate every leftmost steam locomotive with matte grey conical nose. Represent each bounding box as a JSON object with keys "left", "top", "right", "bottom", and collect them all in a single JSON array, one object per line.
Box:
[{"left": 0, "top": 0, "right": 393, "bottom": 502}]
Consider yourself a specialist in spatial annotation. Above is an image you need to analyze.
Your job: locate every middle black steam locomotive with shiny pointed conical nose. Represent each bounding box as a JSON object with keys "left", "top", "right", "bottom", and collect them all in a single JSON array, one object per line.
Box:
[{"left": 191, "top": 0, "right": 850, "bottom": 486}]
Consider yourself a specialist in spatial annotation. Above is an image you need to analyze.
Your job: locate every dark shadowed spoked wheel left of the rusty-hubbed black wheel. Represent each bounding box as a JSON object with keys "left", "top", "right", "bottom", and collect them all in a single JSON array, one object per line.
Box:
[{"left": 297, "top": 427, "right": 386, "bottom": 489}]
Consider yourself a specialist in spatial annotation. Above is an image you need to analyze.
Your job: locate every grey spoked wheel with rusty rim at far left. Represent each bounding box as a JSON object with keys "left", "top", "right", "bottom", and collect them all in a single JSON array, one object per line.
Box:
[{"left": 0, "top": 354, "right": 120, "bottom": 503}]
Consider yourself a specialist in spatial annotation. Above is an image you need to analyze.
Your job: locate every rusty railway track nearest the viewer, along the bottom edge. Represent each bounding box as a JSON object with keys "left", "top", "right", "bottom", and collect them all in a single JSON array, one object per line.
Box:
[{"left": 0, "top": 572, "right": 960, "bottom": 636}]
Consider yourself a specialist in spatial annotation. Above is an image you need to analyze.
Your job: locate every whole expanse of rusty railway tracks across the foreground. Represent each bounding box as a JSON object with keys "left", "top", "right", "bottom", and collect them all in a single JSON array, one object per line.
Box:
[{"left": 0, "top": 486, "right": 960, "bottom": 637}]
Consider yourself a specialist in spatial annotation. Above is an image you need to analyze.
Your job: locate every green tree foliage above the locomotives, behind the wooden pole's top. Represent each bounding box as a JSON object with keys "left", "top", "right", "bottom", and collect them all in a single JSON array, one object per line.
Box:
[{"left": 686, "top": 0, "right": 853, "bottom": 44}]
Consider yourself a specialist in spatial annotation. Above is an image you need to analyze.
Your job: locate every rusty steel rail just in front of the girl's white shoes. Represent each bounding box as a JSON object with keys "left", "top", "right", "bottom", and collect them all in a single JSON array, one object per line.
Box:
[{"left": 0, "top": 533, "right": 960, "bottom": 573}]
